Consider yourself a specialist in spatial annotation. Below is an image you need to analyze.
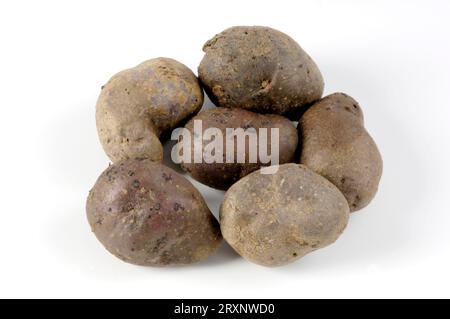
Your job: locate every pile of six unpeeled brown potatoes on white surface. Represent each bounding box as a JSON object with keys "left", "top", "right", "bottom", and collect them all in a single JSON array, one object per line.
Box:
[{"left": 86, "top": 26, "right": 382, "bottom": 266}]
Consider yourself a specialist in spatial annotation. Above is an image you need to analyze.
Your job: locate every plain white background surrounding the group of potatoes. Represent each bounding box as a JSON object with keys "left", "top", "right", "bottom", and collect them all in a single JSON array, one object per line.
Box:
[{"left": 0, "top": 0, "right": 450, "bottom": 298}]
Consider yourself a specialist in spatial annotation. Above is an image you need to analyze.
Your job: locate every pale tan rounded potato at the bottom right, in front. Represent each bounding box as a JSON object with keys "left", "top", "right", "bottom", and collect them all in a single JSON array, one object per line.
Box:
[{"left": 220, "top": 164, "right": 349, "bottom": 266}]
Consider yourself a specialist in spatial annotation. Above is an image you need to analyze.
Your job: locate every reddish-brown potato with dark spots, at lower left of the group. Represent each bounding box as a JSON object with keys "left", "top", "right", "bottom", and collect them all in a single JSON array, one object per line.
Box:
[{"left": 86, "top": 159, "right": 221, "bottom": 266}]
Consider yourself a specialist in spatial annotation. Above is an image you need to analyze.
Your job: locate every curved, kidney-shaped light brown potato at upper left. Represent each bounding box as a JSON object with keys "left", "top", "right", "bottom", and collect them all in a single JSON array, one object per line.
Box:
[{"left": 96, "top": 58, "right": 203, "bottom": 162}]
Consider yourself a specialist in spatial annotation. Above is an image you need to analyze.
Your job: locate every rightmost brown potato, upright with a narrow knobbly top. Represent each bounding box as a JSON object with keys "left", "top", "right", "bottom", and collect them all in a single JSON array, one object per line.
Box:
[{"left": 298, "top": 93, "right": 383, "bottom": 211}]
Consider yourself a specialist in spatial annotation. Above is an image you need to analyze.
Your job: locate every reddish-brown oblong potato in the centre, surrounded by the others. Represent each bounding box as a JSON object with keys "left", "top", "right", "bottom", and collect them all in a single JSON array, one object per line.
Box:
[{"left": 180, "top": 107, "right": 298, "bottom": 190}]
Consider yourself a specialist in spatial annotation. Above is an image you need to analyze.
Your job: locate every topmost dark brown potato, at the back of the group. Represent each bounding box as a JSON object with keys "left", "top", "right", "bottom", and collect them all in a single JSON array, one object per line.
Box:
[{"left": 198, "top": 26, "right": 324, "bottom": 120}]
